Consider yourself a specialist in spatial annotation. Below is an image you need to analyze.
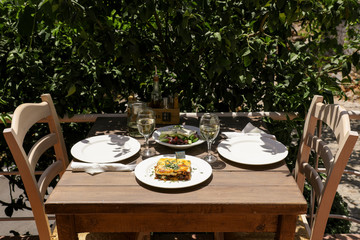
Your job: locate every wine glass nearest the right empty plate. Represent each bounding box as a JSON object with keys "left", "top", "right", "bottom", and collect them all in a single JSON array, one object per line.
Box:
[{"left": 200, "top": 113, "right": 220, "bottom": 163}]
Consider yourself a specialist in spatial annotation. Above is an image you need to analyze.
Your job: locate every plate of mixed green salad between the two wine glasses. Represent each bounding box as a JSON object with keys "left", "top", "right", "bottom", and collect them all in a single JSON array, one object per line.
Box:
[{"left": 153, "top": 125, "right": 204, "bottom": 149}]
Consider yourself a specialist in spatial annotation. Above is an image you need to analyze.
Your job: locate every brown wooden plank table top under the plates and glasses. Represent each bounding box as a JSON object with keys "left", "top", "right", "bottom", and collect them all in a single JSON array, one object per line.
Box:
[{"left": 45, "top": 117, "right": 307, "bottom": 218}]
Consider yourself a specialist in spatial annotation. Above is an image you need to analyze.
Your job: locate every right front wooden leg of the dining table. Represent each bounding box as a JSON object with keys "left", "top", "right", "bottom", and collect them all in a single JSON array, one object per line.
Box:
[{"left": 275, "top": 215, "right": 297, "bottom": 240}]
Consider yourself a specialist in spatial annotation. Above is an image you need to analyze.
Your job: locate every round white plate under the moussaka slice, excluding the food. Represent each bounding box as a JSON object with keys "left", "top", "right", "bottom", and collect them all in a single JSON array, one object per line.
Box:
[{"left": 135, "top": 154, "right": 212, "bottom": 188}]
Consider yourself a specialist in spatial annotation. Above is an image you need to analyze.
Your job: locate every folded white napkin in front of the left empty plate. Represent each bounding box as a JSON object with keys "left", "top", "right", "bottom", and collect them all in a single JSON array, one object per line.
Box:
[{"left": 70, "top": 161, "right": 136, "bottom": 175}]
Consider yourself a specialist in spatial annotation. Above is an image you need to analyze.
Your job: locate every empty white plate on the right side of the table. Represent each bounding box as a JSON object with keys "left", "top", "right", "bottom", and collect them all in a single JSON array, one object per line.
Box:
[{"left": 217, "top": 135, "right": 288, "bottom": 165}]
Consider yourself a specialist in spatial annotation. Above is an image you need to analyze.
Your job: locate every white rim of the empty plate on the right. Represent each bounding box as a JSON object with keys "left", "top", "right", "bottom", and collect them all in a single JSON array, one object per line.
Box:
[{"left": 217, "top": 135, "right": 289, "bottom": 166}]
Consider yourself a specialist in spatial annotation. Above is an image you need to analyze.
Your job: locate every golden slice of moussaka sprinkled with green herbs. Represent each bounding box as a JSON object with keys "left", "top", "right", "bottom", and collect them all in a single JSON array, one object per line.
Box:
[{"left": 155, "top": 158, "right": 191, "bottom": 181}]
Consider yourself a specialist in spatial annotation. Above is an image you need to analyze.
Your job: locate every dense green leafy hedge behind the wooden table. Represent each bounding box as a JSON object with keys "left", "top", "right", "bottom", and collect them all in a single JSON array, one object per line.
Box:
[{"left": 0, "top": 0, "right": 360, "bottom": 234}]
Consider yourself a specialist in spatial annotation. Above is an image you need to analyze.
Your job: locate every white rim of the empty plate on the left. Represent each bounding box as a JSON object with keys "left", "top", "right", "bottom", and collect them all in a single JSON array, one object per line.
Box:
[{"left": 70, "top": 134, "right": 141, "bottom": 163}]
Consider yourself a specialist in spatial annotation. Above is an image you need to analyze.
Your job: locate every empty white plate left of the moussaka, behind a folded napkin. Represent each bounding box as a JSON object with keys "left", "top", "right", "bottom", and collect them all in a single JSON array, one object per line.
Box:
[{"left": 71, "top": 134, "right": 140, "bottom": 163}]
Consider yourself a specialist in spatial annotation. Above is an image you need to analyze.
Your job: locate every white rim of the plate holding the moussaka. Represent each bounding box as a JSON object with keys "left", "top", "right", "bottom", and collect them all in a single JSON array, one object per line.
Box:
[{"left": 134, "top": 154, "right": 213, "bottom": 189}]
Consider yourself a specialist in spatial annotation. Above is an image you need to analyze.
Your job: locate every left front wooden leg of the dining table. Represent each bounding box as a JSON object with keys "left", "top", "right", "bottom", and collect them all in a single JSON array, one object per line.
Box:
[{"left": 56, "top": 215, "right": 78, "bottom": 240}]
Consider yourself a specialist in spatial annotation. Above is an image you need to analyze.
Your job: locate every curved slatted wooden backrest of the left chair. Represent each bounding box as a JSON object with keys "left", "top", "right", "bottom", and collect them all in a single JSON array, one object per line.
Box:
[{"left": 4, "top": 94, "right": 69, "bottom": 240}]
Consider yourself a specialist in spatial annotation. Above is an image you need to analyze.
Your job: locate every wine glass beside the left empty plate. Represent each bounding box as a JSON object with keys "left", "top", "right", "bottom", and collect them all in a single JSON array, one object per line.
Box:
[{"left": 136, "top": 108, "right": 155, "bottom": 157}]
